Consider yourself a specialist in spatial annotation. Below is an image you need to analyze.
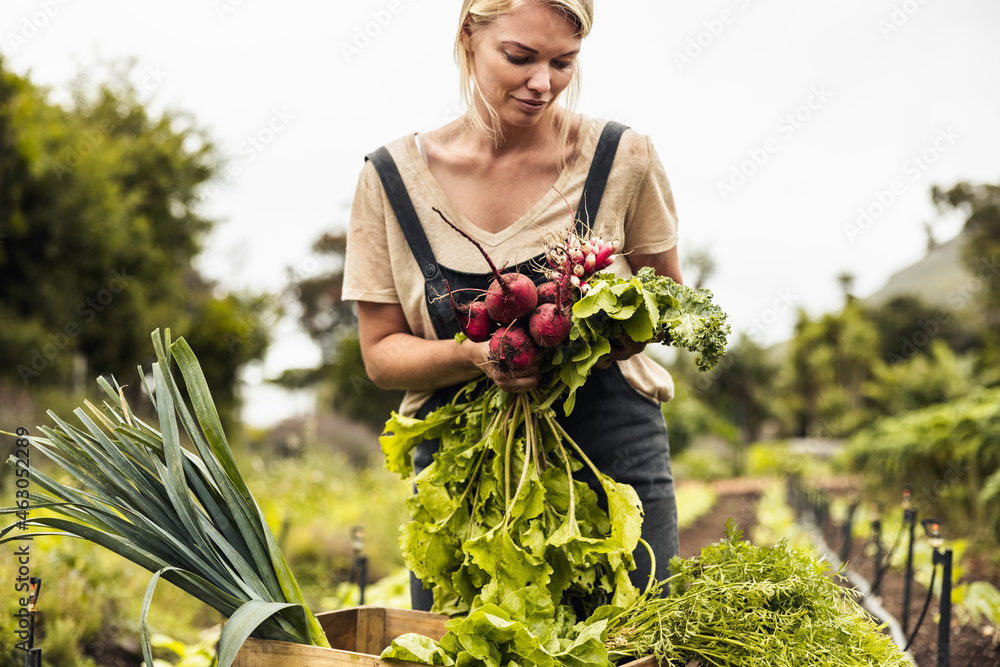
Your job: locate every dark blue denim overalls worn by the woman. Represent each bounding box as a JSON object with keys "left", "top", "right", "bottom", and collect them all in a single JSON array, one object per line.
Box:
[{"left": 366, "top": 122, "right": 678, "bottom": 610}]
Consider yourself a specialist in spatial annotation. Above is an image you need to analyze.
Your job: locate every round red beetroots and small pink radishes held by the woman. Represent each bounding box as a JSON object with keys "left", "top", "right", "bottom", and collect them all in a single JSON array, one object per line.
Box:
[{"left": 434, "top": 208, "right": 615, "bottom": 373}]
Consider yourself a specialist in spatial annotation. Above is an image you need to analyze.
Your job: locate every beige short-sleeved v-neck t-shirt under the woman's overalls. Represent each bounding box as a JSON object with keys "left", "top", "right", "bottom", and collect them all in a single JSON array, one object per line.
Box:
[{"left": 343, "top": 116, "right": 677, "bottom": 415}]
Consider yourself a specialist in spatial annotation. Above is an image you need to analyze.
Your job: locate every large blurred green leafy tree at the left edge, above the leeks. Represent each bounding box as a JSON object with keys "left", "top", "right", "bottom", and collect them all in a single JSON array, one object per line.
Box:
[{"left": 0, "top": 60, "right": 267, "bottom": 422}]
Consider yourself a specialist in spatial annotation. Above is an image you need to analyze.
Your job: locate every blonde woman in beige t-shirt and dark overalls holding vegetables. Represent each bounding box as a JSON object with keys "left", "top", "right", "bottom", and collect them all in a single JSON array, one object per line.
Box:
[{"left": 344, "top": 0, "right": 681, "bottom": 609}]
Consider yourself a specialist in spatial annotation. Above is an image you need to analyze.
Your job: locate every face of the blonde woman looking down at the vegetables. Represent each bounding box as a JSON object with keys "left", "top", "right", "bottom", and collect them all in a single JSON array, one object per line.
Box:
[{"left": 463, "top": 2, "right": 580, "bottom": 127}]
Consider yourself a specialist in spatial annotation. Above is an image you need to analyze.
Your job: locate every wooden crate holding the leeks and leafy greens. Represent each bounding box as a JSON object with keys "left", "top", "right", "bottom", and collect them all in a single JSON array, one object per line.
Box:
[{"left": 233, "top": 607, "right": 656, "bottom": 667}]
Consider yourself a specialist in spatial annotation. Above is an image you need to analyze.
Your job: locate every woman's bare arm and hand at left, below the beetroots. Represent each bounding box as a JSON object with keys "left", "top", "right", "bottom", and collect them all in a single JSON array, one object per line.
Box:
[{"left": 358, "top": 301, "right": 540, "bottom": 391}]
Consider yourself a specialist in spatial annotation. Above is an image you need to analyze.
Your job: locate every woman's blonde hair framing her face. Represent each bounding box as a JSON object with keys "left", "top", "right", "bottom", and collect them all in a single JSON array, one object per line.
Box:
[{"left": 455, "top": 0, "right": 594, "bottom": 145}]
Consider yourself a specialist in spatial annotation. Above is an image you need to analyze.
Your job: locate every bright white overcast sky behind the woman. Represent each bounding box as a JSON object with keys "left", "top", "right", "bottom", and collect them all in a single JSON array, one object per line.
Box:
[{"left": 0, "top": 0, "right": 1000, "bottom": 373}]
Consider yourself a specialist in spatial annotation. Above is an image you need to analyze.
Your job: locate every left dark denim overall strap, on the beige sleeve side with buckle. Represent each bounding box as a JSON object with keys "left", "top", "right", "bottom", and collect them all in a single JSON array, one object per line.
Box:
[{"left": 365, "top": 146, "right": 455, "bottom": 332}]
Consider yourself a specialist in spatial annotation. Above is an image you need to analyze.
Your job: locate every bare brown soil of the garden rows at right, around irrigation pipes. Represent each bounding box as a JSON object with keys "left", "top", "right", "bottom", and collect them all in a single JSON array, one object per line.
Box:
[{"left": 680, "top": 479, "right": 1000, "bottom": 667}]
